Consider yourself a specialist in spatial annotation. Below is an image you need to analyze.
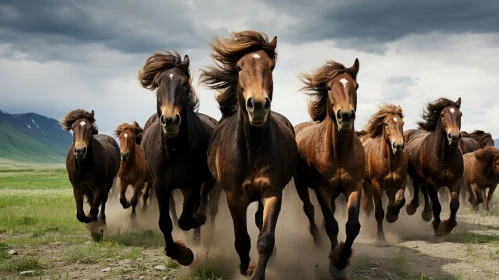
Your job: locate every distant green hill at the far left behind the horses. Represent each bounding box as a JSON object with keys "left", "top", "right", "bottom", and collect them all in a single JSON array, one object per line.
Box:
[{"left": 0, "top": 111, "right": 72, "bottom": 163}]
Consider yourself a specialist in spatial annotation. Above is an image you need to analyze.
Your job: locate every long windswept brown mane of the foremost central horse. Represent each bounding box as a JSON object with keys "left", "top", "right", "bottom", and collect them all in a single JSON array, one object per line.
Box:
[{"left": 200, "top": 31, "right": 277, "bottom": 116}]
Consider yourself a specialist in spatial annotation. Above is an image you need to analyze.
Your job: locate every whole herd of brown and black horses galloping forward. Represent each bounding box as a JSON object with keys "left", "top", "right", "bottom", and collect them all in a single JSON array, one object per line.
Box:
[{"left": 60, "top": 31, "right": 499, "bottom": 279}]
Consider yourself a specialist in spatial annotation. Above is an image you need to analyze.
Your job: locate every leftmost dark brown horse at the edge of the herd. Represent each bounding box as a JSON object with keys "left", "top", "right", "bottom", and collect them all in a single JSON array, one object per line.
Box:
[{"left": 60, "top": 109, "right": 120, "bottom": 223}]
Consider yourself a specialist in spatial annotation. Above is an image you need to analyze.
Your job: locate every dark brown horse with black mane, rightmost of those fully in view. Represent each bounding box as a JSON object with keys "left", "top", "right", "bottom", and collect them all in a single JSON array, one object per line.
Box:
[{"left": 404, "top": 98, "right": 464, "bottom": 236}]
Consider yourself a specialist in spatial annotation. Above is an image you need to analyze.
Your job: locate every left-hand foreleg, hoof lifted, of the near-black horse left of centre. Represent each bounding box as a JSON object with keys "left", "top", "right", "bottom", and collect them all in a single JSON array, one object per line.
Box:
[{"left": 154, "top": 181, "right": 194, "bottom": 266}]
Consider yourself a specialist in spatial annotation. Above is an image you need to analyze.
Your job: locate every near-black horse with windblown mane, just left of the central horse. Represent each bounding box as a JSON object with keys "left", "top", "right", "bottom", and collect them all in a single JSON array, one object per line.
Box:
[{"left": 138, "top": 50, "right": 217, "bottom": 266}]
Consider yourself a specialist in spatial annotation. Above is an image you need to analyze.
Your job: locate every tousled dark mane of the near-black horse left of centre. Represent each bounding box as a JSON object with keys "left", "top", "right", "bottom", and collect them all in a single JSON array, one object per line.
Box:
[{"left": 138, "top": 50, "right": 199, "bottom": 111}]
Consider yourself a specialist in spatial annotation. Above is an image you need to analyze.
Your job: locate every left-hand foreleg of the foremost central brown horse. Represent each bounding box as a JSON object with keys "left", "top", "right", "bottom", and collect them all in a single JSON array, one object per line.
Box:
[{"left": 225, "top": 192, "right": 254, "bottom": 276}]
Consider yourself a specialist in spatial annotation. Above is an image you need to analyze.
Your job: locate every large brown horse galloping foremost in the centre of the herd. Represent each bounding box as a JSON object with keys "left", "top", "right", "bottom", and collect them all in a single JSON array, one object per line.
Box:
[{"left": 200, "top": 30, "right": 297, "bottom": 279}]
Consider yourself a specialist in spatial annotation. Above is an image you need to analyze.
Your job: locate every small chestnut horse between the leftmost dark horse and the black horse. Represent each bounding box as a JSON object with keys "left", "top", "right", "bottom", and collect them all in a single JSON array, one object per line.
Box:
[{"left": 115, "top": 122, "right": 152, "bottom": 215}]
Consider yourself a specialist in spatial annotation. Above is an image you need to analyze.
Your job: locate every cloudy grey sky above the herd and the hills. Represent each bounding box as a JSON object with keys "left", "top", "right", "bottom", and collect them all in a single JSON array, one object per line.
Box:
[{"left": 0, "top": 0, "right": 499, "bottom": 138}]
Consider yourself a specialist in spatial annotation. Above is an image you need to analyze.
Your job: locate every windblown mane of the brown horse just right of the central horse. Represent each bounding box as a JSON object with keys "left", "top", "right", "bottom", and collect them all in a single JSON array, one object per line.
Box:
[{"left": 298, "top": 60, "right": 357, "bottom": 121}]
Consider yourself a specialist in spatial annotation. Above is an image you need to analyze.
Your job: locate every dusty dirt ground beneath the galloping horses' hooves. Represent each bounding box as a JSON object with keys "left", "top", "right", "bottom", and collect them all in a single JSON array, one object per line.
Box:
[{"left": 0, "top": 184, "right": 499, "bottom": 279}]
